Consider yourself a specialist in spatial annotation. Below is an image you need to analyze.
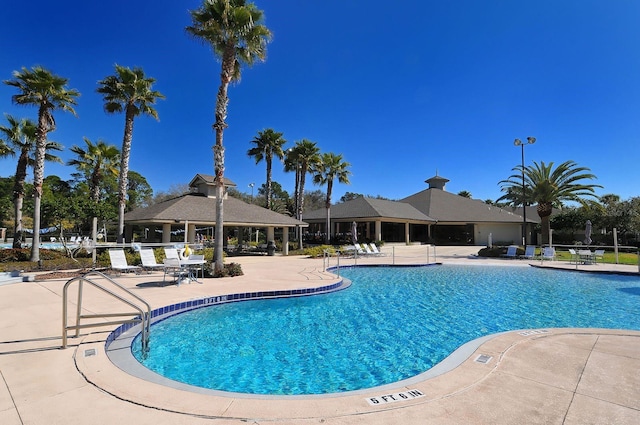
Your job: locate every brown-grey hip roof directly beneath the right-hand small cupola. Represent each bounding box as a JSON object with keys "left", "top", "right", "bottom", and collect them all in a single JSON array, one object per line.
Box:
[{"left": 400, "top": 189, "right": 535, "bottom": 223}]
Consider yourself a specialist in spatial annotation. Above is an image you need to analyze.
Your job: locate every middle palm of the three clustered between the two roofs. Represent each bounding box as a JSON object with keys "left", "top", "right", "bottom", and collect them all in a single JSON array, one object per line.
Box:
[{"left": 284, "top": 139, "right": 320, "bottom": 249}]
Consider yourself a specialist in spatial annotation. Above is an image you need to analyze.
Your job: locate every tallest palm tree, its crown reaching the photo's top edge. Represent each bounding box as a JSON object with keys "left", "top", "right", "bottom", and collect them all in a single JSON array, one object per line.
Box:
[{"left": 186, "top": 0, "right": 271, "bottom": 274}]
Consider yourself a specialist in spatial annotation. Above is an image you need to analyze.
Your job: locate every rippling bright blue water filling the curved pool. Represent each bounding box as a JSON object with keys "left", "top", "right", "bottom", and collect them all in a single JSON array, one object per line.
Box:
[{"left": 134, "top": 265, "right": 640, "bottom": 395}]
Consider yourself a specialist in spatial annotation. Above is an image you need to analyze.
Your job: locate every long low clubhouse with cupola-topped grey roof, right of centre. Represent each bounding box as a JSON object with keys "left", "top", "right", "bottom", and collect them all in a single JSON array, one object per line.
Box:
[{"left": 304, "top": 175, "right": 536, "bottom": 245}]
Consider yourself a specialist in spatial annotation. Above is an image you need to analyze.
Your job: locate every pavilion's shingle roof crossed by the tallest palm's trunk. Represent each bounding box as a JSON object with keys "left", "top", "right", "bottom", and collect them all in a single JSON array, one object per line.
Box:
[{"left": 124, "top": 193, "right": 308, "bottom": 227}]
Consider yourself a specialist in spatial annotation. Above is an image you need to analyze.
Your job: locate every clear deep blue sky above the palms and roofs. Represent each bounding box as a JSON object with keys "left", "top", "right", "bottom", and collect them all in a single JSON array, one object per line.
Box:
[{"left": 0, "top": 0, "right": 640, "bottom": 201}]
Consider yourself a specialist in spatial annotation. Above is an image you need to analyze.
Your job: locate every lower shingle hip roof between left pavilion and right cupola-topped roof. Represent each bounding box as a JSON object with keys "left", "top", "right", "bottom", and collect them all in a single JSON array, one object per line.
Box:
[{"left": 303, "top": 197, "right": 435, "bottom": 222}]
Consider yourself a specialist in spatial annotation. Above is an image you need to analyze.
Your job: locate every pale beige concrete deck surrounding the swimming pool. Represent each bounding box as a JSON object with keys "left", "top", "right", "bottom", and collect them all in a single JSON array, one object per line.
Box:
[{"left": 0, "top": 243, "right": 640, "bottom": 425}]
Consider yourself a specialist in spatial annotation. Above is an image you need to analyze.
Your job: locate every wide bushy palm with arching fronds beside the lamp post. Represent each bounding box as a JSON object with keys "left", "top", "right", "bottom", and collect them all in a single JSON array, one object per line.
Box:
[{"left": 496, "top": 161, "right": 602, "bottom": 244}]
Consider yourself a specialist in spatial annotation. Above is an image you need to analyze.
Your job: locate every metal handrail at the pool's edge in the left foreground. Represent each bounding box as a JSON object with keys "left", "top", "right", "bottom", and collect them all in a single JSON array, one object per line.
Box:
[{"left": 62, "top": 270, "right": 151, "bottom": 351}]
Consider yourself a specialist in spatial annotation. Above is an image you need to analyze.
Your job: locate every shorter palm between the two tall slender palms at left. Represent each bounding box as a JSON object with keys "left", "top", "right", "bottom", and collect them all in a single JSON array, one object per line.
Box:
[{"left": 67, "top": 137, "right": 120, "bottom": 203}]
